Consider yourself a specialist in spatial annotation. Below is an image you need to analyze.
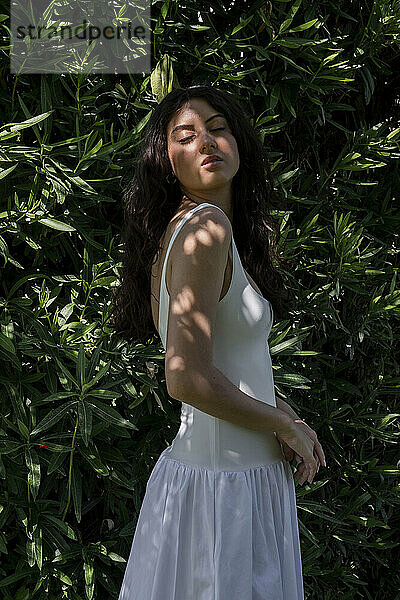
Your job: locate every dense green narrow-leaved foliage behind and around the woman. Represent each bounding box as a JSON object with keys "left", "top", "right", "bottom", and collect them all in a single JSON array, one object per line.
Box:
[{"left": 0, "top": 0, "right": 400, "bottom": 600}]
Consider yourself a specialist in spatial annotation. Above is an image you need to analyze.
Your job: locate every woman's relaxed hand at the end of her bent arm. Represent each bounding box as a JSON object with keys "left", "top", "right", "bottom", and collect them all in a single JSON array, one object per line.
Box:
[{"left": 275, "top": 419, "right": 326, "bottom": 485}]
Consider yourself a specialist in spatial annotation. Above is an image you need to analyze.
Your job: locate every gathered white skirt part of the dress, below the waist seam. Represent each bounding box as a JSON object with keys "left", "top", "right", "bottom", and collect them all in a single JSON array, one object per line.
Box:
[{"left": 118, "top": 448, "right": 304, "bottom": 600}]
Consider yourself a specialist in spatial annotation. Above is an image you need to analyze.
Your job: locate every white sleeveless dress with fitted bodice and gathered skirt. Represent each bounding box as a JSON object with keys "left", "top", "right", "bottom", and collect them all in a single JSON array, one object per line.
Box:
[{"left": 118, "top": 202, "right": 304, "bottom": 600}]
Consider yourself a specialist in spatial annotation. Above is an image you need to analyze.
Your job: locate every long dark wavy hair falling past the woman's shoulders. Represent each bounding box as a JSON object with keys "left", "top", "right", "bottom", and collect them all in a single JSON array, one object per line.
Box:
[{"left": 110, "top": 85, "right": 292, "bottom": 343}]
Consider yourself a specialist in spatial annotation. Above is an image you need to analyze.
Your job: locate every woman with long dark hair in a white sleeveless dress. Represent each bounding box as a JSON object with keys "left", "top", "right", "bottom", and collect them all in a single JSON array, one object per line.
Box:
[{"left": 114, "top": 86, "right": 325, "bottom": 600}]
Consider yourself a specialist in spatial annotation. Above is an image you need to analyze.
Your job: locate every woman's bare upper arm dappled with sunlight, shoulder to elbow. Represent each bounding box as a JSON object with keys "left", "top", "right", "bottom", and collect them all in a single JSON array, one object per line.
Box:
[{"left": 165, "top": 206, "right": 232, "bottom": 397}]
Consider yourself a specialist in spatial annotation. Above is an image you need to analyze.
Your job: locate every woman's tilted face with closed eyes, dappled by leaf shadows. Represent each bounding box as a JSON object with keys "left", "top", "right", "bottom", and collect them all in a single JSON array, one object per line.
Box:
[{"left": 167, "top": 98, "right": 240, "bottom": 200}]
